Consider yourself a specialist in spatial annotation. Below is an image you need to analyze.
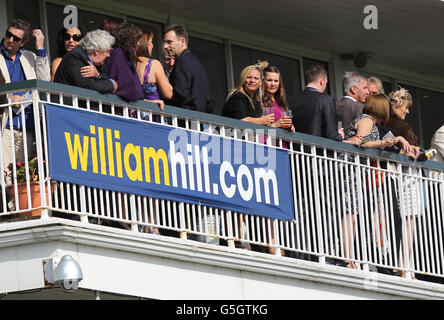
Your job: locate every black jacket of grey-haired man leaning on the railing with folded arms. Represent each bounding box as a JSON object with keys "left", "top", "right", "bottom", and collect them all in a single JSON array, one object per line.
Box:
[{"left": 54, "top": 46, "right": 114, "bottom": 93}]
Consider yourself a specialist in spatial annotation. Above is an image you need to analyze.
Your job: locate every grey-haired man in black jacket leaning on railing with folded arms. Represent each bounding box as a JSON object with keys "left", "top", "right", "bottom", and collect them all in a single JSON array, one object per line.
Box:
[{"left": 54, "top": 30, "right": 118, "bottom": 93}]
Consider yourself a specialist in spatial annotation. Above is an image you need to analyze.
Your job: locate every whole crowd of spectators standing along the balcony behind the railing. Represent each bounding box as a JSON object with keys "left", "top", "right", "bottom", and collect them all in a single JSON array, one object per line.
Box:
[{"left": 0, "top": 19, "right": 444, "bottom": 278}]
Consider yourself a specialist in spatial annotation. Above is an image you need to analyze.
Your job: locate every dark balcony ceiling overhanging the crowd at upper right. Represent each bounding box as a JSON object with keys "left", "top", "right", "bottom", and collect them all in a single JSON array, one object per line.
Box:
[{"left": 122, "top": 0, "right": 444, "bottom": 77}]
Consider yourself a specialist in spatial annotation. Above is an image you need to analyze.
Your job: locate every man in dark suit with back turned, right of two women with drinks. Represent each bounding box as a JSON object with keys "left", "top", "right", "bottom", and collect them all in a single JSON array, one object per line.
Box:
[{"left": 289, "top": 65, "right": 343, "bottom": 141}]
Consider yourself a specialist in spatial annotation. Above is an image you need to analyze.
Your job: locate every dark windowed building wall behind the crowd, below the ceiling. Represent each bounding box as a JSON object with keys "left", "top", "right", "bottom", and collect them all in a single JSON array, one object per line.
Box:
[{"left": 0, "top": 0, "right": 444, "bottom": 148}]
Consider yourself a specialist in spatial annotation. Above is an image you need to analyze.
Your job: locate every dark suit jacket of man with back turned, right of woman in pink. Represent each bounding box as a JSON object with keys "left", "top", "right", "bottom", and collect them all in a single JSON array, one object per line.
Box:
[{"left": 288, "top": 87, "right": 342, "bottom": 141}]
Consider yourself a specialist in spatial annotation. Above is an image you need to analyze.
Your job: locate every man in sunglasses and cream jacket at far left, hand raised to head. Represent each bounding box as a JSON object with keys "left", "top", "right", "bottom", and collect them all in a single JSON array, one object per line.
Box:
[{"left": 0, "top": 19, "right": 50, "bottom": 209}]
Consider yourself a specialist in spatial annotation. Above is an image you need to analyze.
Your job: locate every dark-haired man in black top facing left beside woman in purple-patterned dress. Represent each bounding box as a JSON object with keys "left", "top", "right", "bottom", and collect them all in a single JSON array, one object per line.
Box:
[{"left": 163, "top": 25, "right": 214, "bottom": 112}]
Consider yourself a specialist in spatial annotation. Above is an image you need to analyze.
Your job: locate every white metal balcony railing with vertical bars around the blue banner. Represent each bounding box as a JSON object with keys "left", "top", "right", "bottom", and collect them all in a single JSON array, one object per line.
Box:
[{"left": 0, "top": 80, "right": 444, "bottom": 277}]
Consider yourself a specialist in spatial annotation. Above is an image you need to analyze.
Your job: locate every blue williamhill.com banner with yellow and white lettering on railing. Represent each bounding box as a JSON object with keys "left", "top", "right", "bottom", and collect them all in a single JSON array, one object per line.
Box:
[{"left": 45, "top": 104, "right": 294, "bottom": 220}]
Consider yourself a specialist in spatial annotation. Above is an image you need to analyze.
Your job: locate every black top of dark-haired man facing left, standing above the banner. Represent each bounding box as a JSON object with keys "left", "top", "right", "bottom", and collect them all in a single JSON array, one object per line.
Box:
[{"left": 166, "top": 49, "right": 214, "bottom": 112}]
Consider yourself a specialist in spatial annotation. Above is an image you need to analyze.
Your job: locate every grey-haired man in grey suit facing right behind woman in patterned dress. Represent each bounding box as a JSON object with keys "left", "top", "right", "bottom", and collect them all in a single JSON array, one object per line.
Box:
[{"left": 336, "top": 72, "right": 370, "bottom": 130}]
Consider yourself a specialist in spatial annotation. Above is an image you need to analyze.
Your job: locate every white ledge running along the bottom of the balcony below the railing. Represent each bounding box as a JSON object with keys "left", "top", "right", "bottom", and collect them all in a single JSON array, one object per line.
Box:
[{"left": 0, "top": 218, "right": 444, "bottom": 299}]
